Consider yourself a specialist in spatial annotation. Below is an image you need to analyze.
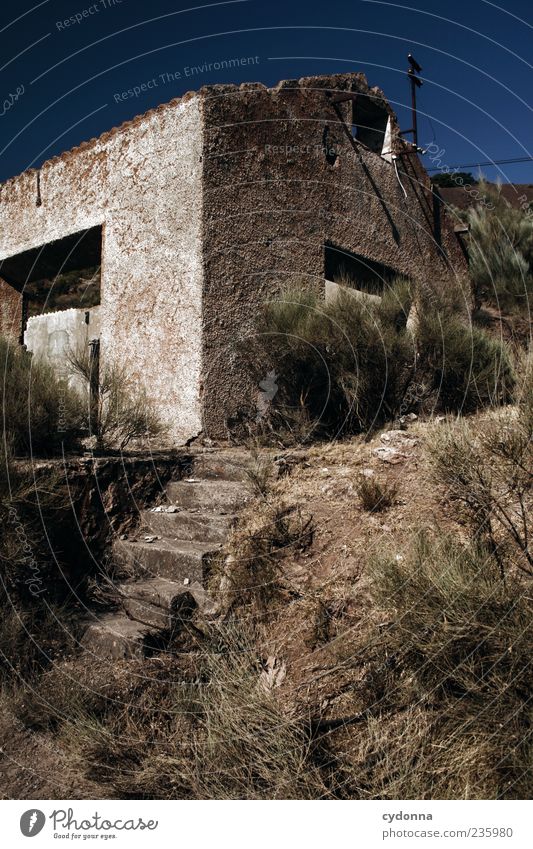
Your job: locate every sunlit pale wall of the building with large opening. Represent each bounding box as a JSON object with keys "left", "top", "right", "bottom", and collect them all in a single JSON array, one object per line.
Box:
[{"left": 0, "top": 96, "right": 202, "bottom": 443}]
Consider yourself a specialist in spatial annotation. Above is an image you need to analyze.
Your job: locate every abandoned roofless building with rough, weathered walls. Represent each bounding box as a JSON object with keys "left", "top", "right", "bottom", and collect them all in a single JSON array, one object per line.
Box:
[{"left": 0, "top": 73, "right": 465, "bottom": 444}]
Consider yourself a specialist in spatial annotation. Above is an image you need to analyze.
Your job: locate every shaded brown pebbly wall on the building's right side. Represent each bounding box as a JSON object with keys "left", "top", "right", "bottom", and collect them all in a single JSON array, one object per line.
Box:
[{"left": 203, "top": 74, "right": 465, "bottom": 437}]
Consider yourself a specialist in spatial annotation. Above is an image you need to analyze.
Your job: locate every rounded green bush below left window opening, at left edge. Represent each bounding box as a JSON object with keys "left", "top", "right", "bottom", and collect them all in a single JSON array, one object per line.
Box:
[{"left": 0, "top": 338, "right": 81, "bottom": 456}]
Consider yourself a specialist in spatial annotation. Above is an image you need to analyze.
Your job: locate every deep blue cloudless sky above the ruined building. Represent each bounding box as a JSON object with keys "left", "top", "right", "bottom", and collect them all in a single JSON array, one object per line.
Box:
[{"left": 0, "top": 0, "right": 533, "bottom": 183}]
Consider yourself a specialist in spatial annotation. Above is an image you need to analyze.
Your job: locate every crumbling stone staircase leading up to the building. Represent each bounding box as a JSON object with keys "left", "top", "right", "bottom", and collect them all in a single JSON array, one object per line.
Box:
[{"left": 81, "top": 450, "right": 251, "bottom": 659}]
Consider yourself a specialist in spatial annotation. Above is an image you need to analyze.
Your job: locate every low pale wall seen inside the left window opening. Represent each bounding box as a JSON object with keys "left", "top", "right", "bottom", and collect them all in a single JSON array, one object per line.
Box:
[{"left": 24, "top": 307, "right": 100, "bottom": 392}]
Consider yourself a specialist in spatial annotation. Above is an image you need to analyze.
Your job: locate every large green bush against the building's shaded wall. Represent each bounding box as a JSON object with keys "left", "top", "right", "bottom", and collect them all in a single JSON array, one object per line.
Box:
[{"left": 255, "top": 279, "right": 514, "bottom": 441}]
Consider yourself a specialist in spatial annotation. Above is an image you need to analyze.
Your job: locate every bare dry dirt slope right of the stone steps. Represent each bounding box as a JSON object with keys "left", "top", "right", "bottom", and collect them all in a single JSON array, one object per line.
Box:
[{"left": 241, "top": 417, "right": 466, "bottom": 717}]
